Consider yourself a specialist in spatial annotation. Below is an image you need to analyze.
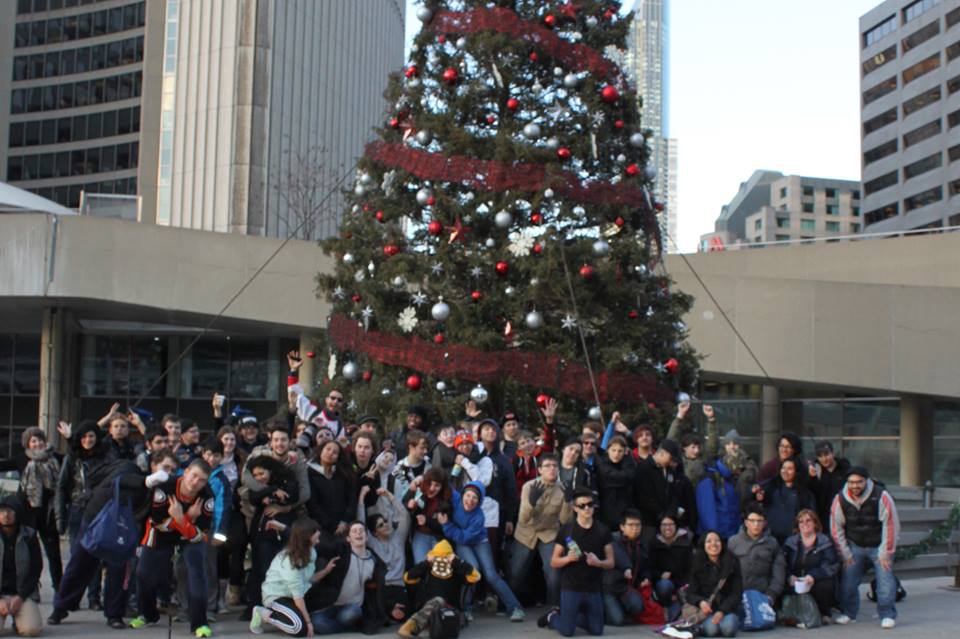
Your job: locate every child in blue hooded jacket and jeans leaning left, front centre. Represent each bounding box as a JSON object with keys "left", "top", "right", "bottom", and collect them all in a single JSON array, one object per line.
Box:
[{"left": 437, "top": 481, "right": 525, "bottom": 622}]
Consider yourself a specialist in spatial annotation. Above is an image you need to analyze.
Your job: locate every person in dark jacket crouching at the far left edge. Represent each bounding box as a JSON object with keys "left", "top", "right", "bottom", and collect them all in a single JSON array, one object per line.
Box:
[{"left": 0, "top": 495, "right": 43, "bottom": 637}]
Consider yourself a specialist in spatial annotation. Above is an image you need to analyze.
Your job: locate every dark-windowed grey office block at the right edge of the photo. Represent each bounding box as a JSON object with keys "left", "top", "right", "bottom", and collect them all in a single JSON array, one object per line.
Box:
[{"left": 860, "top": 0, "right": 960, "bottom": 232}]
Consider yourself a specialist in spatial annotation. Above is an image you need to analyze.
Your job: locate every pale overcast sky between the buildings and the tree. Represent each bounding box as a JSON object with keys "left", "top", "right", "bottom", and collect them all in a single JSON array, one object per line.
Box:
[{"left": 407, "top": 0, "right": 880, "bottom": 252}]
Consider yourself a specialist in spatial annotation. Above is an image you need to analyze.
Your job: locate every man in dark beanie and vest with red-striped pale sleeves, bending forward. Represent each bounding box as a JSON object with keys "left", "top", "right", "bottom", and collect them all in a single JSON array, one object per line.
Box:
[{"left": 830, "top": 466, "right": 900, "bottom": 629}]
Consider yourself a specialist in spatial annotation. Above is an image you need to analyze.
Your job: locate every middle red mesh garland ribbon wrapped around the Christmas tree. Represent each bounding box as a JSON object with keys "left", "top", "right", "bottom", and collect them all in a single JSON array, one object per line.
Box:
[{"left": 366, "top": 142, "right": 661, "bottom": 248}]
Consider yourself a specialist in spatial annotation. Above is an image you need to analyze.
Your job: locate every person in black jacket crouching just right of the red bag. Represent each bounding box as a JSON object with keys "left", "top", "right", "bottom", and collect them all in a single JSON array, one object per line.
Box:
[{"left": 649, "top": 513, "right": 692, "bottom": 621}]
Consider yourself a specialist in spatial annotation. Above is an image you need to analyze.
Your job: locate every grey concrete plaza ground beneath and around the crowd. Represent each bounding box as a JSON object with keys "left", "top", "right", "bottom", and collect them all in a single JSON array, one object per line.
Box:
[{"left": 31, "top": 577, "right": 960, "bottom": 639}]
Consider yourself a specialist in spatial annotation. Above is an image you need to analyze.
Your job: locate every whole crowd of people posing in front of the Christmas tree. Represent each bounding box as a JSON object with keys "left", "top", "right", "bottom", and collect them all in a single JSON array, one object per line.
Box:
[{"left": 0, "top": 352, "right": 899, "bottom": 637}]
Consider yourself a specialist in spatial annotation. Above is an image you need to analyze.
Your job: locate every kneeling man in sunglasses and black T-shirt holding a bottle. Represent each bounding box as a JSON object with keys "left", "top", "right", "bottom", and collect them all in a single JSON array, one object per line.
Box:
[{"left": 537, "top": 488, "right": 615, "bottom": 637}]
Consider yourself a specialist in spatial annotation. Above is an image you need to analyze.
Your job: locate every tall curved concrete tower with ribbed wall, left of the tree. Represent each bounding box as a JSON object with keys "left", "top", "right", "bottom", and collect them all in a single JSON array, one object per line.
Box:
[{"left": 0, "top": 0, "right": 404, "bottom": 238}]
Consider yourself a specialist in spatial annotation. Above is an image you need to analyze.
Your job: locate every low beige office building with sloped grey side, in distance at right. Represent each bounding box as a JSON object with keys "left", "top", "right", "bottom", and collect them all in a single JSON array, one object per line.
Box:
[{"left": 700, "top": 171, "right": 863, "bottom": 251}]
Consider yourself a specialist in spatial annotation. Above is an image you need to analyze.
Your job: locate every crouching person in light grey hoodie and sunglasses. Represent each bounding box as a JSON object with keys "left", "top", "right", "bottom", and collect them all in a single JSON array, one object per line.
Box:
[{"left": 357, "top": 486, "right": 410, "bottom": 622}]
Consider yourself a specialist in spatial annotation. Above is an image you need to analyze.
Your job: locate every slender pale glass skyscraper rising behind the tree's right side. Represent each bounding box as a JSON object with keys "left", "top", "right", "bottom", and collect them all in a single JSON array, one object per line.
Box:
[{"left": 626, "top": 0, "right": 678, "bottom": 252}]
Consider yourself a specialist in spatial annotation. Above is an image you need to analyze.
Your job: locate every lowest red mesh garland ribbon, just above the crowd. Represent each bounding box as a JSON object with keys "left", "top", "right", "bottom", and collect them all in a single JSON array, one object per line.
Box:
[{"left": 327, "top": 315, "right": 672, "bottom": 404}]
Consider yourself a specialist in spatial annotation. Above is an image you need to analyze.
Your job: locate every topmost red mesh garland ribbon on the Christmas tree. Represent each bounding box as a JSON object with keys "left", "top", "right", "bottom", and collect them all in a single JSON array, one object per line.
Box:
[{"left": 427, "top": 7, "right": 626, "bottom": 89}]
